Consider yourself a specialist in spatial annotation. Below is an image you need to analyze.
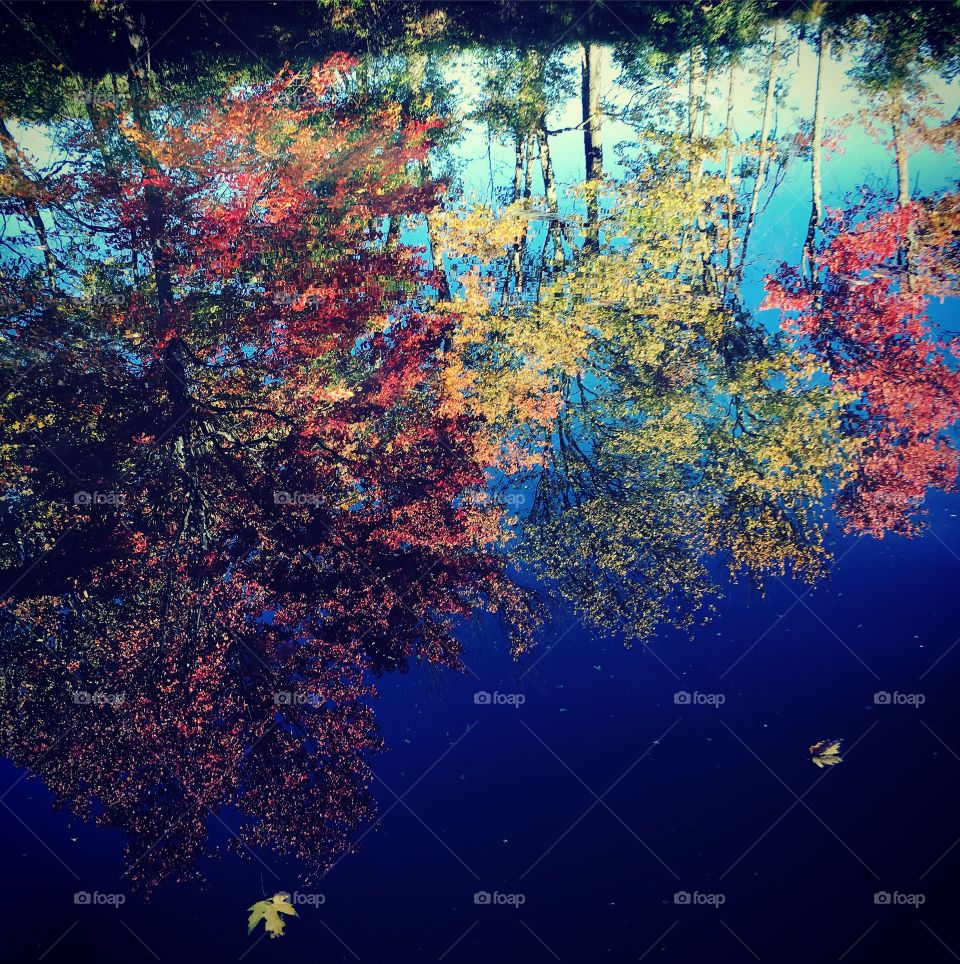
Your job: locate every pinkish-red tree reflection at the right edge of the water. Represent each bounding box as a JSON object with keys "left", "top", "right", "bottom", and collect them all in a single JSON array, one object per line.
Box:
[{"left": 766, "top": 199, "right": 960, "bottom": 536}]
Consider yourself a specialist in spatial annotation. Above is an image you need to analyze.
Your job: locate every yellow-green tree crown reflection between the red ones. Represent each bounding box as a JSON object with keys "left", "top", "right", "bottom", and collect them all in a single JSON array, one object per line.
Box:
[{"left": 438, "top": 143, "right": 849, "bottom": 638}]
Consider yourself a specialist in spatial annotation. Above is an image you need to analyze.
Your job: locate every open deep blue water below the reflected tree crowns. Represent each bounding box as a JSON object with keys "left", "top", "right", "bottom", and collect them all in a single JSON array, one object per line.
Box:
[{"left": 7, "top": 497, "right": 960, "bottom": 962}]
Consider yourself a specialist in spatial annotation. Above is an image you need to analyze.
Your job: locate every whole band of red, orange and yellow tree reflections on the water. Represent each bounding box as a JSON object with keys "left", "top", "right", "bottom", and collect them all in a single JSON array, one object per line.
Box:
[{"left": 0, "top": 4, "right": 960, "bottom": 887}]
